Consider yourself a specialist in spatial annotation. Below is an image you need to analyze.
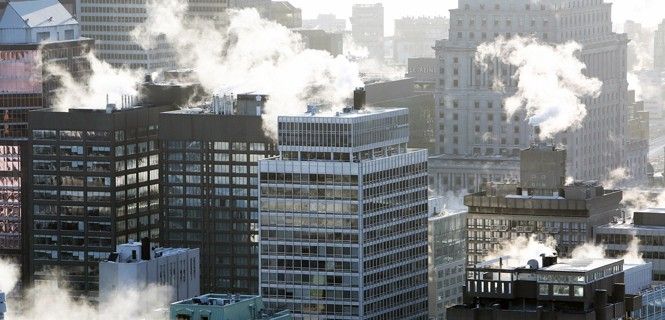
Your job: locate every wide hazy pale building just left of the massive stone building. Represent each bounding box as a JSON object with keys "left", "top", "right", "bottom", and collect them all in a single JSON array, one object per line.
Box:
[{"left": 393, "top": 17, "right": 449, "bottom": 65}]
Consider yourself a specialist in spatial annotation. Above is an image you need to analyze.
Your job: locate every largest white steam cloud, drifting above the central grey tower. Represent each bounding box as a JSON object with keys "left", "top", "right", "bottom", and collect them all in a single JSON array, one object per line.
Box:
[{"left": 134, "top": 0, "right": 363, "bottom": 136}]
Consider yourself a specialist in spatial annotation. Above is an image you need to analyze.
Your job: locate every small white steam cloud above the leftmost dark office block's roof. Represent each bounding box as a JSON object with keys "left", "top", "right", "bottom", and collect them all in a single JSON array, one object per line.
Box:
[{"left": 45, "top": 52, "right": 143, "bottom": 110}]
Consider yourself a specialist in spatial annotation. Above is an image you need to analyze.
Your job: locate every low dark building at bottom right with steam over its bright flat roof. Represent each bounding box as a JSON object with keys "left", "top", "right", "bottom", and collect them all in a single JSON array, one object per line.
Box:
[{"left": 447, "top": 253, "right": 651, "bottom": 320}]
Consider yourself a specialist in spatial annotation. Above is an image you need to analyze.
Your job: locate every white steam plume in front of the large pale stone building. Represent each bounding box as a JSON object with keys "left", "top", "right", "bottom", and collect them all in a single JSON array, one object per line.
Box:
[{"left": 476, "top": 37, "right": 602, "bottom": 139}]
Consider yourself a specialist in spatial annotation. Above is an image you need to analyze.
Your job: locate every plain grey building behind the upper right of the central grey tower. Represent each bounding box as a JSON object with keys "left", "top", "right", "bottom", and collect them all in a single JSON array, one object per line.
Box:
[{"left": 365, "top": 78, "right": 435, "bottom": 154}]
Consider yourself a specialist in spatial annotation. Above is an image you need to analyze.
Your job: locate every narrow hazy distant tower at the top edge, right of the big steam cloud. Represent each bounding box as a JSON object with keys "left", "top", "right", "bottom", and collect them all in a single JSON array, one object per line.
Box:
[{"left": 351, "top": 3, "right": 385, "bottom": 61}]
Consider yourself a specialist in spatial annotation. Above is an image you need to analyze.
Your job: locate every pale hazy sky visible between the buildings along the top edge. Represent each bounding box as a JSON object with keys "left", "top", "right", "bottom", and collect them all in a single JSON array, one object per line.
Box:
[{"left": 289, "top": 0, "right": 665, "bottom": 36}]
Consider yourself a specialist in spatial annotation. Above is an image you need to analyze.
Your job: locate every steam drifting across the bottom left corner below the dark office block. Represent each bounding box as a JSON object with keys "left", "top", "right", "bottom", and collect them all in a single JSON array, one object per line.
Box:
[{"left": 0, "top": 261, "right": 172, "bottom": 320}]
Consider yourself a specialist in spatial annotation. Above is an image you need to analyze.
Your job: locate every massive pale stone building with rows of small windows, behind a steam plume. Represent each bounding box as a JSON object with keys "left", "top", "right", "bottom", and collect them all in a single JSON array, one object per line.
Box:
[{"left": 431, "top": 0, "right": 641, "bottom": 192}]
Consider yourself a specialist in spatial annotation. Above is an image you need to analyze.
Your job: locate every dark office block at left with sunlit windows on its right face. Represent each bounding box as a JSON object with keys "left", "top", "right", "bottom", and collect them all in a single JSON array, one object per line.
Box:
[{"left": 23, "top": 105, "right": 173, "bottom": 299}]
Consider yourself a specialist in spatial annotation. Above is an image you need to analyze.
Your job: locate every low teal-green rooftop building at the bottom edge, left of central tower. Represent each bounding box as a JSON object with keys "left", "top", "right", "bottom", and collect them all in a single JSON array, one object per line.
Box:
[{"left": 169, "top": 294, "right": 293, "bottom": 320}]
